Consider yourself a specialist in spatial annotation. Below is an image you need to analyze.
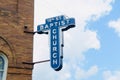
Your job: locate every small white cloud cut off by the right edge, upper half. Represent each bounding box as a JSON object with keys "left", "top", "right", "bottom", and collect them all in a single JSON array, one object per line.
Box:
[{"left": 108, "top": 18, "right": 120, "bottom": 37}]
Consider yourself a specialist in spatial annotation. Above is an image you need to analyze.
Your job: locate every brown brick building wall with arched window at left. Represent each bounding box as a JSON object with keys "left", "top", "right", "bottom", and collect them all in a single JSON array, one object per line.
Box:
[{"left": 0, "top": 0, "right": 34, "bottom": 80}]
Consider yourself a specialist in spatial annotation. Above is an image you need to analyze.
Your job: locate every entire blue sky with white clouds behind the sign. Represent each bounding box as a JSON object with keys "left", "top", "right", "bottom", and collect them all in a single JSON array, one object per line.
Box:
[{"left": 32, "top": 0, "right": 120, "bottom": 80}]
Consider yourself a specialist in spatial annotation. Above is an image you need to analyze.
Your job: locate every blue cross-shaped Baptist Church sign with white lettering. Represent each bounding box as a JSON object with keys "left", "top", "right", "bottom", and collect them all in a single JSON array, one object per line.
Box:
[{"left": 37, "top": 15, "right": 75, "bottom": 71}]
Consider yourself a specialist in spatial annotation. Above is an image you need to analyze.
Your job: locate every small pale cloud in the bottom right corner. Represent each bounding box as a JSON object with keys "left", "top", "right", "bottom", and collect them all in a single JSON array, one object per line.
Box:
[{"left": 103, "top": 70, "right": 120, "bottom": 80}]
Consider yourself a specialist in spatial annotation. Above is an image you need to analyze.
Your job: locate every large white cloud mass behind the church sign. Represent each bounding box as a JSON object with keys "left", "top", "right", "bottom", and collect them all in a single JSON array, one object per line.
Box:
[{"left": 33, "top": 0, "right": 113, "bottom": 80}]
